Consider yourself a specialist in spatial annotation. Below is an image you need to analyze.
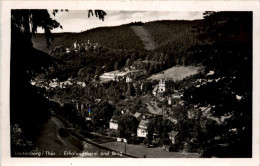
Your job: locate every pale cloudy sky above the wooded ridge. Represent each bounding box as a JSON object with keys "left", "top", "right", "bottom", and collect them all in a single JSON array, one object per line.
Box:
[{"left": 42, "top": 10, "right": 203, "bottom": 33}]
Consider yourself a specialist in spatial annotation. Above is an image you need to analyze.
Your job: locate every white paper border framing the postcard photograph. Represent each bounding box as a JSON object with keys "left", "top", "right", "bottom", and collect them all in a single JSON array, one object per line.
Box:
[{"left": 0, "top": 0, "right": 260, "bottom": 166}]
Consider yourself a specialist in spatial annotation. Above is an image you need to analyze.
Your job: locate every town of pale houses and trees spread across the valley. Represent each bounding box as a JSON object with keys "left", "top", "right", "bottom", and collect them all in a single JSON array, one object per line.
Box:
[{"left": 31, "top": 39, "right": 226, "bottom": 157}]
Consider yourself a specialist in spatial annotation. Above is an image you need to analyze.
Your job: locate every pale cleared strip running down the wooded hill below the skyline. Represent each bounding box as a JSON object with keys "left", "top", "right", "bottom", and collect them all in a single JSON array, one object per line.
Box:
[{"left": 130, "top": 26, "right": 156, "bottom": 50}]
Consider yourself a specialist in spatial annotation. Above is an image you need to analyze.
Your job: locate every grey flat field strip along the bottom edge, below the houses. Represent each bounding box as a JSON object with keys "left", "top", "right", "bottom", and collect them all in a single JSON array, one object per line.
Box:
[{"left": 102, "top": 142, "right": 200, "bottom": 158}]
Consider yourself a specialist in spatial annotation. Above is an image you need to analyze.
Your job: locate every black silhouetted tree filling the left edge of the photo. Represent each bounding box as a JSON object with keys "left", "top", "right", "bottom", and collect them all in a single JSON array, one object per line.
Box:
[{"left": 10, "top": 9, "right": 104, "bottom": 156}]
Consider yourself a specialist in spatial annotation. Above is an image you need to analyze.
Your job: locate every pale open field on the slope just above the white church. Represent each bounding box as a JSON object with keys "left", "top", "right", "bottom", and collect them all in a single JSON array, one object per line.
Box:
[{"left": 148, "top": 66, "right": 202, "bottom": 81}]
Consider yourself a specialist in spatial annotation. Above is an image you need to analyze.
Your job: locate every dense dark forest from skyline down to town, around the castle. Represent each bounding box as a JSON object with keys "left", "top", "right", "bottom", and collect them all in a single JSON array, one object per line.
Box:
[{"left": 32, "top": 20, "right": 203, "bottom": 80}]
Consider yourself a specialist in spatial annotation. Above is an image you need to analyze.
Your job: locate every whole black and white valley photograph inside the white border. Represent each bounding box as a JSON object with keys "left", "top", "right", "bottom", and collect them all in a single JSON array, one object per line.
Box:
[{"left": 0, "top": 0, "right": 259, "bottom": 165}]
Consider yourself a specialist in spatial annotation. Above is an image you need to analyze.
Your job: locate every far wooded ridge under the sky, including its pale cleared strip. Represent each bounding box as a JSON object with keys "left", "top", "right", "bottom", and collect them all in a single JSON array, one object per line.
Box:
[{"left": 32, "top": 21, "right": 197, "bottom": 52}]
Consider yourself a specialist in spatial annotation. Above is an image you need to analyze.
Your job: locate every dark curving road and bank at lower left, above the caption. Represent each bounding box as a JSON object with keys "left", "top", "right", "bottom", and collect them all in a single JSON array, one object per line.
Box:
[{"left": 35, "top": 116, "right": 134, "bottom": 158}]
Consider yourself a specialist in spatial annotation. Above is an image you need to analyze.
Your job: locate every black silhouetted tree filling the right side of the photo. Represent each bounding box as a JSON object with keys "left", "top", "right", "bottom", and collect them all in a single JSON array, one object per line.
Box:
[{"left": 184, "top": 12, "right": 252, "bottom": 157}]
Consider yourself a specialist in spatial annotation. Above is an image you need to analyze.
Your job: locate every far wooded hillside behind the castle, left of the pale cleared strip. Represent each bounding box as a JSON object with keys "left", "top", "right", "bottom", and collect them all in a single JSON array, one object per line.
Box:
[{"left": 32, "top": 25, "right": 144, "bottom": 52}]
